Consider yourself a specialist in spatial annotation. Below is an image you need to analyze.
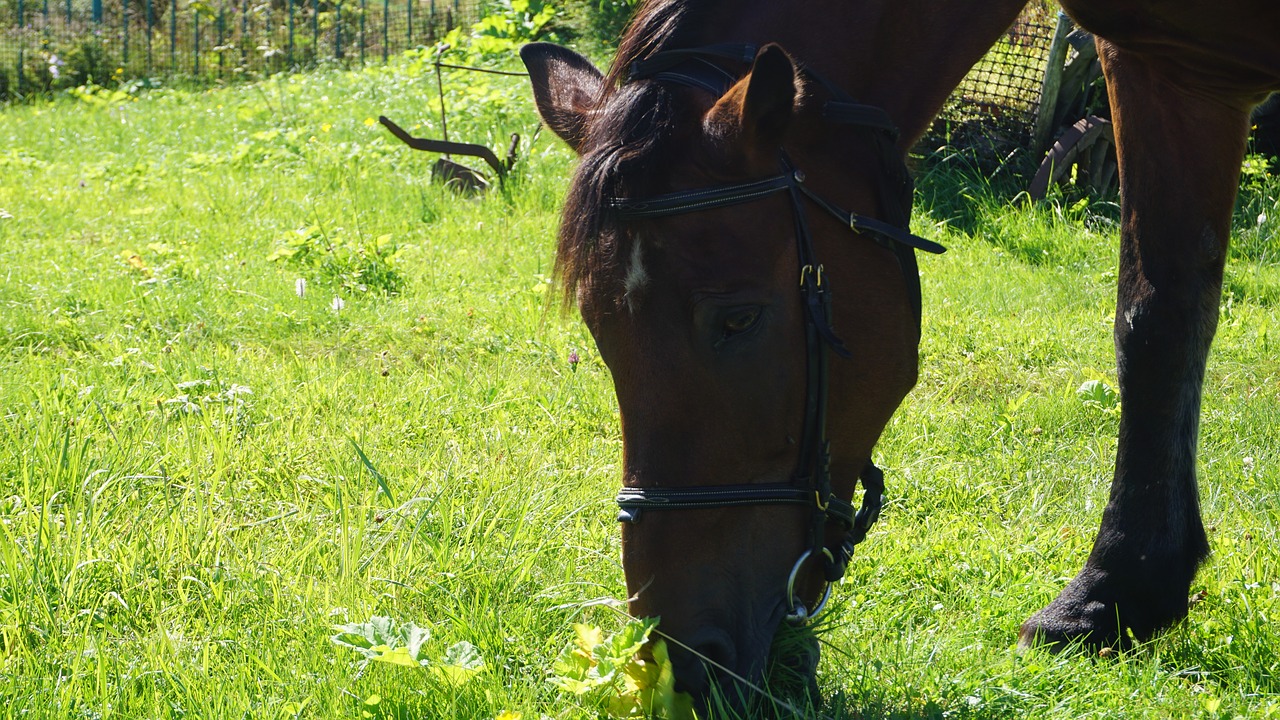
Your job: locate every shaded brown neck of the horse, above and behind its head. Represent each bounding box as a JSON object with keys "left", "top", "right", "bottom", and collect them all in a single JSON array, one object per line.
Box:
[{"left": 699, "top": 0, "right": 1027, "bottom": 147}]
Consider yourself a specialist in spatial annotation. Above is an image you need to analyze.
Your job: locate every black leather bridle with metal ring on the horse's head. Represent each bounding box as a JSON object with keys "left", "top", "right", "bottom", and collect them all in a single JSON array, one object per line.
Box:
[{"left": 608, "top": 45, "right": 946, "bottom": 624}]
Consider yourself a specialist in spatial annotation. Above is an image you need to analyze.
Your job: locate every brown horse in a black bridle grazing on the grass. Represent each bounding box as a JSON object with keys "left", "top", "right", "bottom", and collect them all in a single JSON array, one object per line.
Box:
[{"left": 522, "top": 0, "right": 1280, "bottom": 692}]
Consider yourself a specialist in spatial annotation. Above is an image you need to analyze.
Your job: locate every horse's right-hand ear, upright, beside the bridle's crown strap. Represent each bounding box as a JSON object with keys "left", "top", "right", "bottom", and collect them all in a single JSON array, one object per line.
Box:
[{"left": 708, "top": 42, "right": 797, "bottom": 149}]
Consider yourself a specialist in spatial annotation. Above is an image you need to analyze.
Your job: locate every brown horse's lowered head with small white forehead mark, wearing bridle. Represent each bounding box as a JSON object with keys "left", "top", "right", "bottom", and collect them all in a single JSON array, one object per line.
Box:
[{"left": 522, "top": 44, "right": 932, "bottom": 693}]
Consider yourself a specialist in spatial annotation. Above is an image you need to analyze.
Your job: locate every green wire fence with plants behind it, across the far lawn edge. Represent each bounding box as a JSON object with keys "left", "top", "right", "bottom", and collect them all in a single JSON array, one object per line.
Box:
[{"left": 0, "top": 0, "right": 488, "bottom": 100}]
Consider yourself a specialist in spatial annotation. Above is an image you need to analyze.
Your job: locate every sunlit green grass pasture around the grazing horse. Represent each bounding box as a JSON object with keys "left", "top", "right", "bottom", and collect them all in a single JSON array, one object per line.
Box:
[{"left": 0, "top": 58, "right": 1280, "bottom": 720}]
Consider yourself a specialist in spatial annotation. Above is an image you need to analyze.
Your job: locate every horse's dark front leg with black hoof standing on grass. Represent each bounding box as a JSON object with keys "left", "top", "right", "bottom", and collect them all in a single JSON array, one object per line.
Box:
[{"left": 1020, "top": 40, "right": 1249, "bottom": 646}]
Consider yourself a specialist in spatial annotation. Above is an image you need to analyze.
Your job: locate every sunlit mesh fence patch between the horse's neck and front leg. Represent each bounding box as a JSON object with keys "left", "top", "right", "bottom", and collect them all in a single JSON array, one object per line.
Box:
[{"left": 922, "top": 3, "right": 1057, "bottom": 159}]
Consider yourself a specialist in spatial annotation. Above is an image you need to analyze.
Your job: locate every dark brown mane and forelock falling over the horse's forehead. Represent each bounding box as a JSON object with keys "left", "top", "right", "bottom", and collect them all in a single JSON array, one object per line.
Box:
[{"left": 554, "top": 0, "right": 714, "bottom": 310}]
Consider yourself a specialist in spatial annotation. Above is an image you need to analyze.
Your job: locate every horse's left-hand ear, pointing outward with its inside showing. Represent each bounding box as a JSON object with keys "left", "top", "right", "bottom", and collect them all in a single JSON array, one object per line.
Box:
[{"left": 520, "top": 42, "right": 604, "bottom": 154}]
